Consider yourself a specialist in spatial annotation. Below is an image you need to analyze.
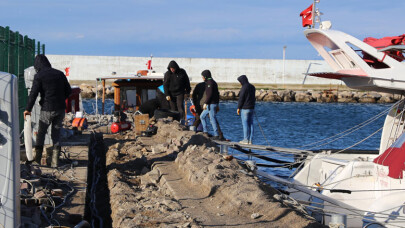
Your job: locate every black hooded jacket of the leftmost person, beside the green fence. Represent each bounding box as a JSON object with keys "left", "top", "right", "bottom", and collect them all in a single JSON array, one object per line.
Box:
[{"left": 26, "top": 55, "right": 72, "bottom": 112}]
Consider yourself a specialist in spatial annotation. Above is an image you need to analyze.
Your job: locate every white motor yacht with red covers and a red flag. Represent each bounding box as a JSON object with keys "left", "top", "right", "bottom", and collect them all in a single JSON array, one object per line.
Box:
[{"left": 258, "top": 1, "right": 405, "bottom": 227}]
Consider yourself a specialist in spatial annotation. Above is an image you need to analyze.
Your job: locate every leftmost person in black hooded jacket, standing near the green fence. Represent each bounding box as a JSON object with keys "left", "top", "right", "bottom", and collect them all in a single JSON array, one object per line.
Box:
[{"left": 24, "top": 54, "right": 72, "bottom": 167}]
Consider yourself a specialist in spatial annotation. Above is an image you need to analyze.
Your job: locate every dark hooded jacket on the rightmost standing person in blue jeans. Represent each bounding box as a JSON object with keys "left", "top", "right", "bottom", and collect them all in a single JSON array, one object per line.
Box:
[{"left": 238, "top": 75, "right": 256, "bottom": 109}]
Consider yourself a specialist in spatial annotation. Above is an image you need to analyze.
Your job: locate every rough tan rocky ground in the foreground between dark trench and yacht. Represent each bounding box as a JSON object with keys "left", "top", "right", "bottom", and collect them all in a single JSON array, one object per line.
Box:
[{"left": 104, "top": 119, "right": 323, "bottom": 228}]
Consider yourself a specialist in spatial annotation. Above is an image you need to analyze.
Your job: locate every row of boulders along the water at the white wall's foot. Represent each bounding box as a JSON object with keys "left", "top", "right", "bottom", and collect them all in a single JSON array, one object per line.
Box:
[{"left": 76, "top": 84, "right": 401, "bottom": 103}]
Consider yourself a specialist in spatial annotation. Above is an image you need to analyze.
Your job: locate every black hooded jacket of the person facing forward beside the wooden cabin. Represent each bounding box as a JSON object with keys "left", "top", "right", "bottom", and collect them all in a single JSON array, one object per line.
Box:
[{"left": 163, "top": 60, "right": 191, "bottom": 96}]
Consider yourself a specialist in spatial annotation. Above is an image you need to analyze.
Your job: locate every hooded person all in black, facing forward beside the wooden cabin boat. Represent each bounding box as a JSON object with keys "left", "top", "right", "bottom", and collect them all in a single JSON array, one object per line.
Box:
[{"left": 163, "top": 60, "right": 191, "bottom": 120}]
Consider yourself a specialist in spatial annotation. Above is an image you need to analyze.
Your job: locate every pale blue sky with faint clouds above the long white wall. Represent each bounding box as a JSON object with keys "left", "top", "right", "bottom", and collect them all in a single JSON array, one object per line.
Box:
[{"left": 0, "top": 0, "right": 405, "bottom": 59}]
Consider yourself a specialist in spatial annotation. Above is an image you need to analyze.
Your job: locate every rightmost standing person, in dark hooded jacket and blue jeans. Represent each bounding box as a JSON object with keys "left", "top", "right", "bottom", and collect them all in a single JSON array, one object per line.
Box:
[{"left": 237, "top": 75, "right": 256, "bottom": 144}]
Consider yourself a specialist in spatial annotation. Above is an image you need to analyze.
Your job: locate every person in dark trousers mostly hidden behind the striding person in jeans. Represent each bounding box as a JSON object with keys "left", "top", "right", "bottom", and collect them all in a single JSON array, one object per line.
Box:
[{"left": 192, "top": 82, "right": 225, "bottom": 140}]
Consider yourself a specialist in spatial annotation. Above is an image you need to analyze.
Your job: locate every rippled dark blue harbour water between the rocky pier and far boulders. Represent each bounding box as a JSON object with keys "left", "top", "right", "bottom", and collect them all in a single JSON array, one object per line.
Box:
[{"left": 83, "top": 99, "right": 391, "bottom": 181}]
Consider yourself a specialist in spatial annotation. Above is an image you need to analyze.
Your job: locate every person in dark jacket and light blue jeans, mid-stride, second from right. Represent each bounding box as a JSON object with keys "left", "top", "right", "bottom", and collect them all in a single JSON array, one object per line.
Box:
[{"left": 200, "top": 70, "right": 219, "bottom": 140}]
